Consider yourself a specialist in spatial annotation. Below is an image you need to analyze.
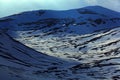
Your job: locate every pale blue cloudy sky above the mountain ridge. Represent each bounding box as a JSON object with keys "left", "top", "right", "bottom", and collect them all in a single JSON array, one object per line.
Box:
[{"left": 0, "top": 0, "right": 120, "bottom": 17}]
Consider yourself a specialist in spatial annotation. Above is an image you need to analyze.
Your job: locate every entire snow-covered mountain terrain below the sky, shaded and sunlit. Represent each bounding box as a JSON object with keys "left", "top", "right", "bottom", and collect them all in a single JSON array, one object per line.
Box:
[{"left": 0, "top": 6, "right": 120, "bottom": 80}]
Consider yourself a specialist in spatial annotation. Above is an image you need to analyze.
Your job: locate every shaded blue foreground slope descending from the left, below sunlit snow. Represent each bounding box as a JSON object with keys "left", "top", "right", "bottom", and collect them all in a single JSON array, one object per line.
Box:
[{"left": 0, "top": 31, "right": 119, "bottom": 80}]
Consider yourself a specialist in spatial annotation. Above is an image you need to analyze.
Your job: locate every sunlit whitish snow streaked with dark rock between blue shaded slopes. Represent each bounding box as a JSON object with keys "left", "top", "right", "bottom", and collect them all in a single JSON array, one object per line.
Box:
[{"left": 14, "top": 28, "right": 120, "bottom": 61}]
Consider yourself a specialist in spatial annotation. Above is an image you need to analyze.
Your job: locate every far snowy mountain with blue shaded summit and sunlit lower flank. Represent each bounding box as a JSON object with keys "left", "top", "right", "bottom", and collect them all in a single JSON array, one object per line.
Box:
[{"left": 0, "top": 6, "right": 120, "bottom": 58}]
